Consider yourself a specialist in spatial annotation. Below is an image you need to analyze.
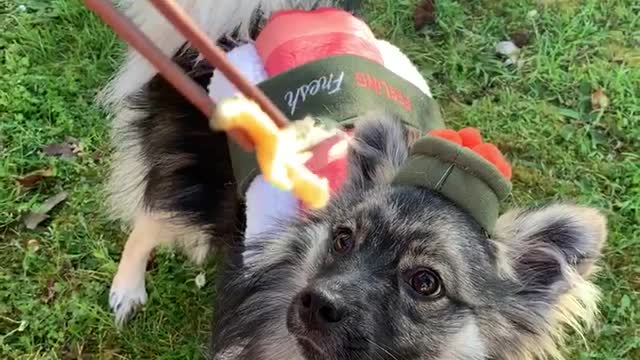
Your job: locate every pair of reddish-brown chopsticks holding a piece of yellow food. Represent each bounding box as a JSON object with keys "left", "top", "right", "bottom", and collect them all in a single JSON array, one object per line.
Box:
[{"left": 84, "top": 0, "right": 288, "bottom": 150}]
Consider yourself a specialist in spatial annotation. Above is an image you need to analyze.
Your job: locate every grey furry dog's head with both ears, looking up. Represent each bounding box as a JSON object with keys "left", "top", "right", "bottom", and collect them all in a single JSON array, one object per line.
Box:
[{"left": 213, "top": 112, "right": 606, "bottom": 360}]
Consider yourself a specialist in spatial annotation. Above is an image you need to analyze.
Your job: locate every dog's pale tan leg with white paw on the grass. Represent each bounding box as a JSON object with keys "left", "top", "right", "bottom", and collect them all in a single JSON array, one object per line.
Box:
[{"left": 109, "top": 213, "right": 172, "bottom": 326}]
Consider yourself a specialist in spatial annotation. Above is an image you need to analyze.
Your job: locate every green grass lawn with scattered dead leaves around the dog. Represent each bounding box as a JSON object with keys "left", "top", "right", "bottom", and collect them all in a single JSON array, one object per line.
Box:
[{"left": 0, "top": 0, "right": 640, "bottom": 359}]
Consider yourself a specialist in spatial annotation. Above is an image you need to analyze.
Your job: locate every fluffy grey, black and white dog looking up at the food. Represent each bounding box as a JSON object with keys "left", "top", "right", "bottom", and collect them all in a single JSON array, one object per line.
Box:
[{"left": 100, "top": 0, "right": 607, "bottom": 360}]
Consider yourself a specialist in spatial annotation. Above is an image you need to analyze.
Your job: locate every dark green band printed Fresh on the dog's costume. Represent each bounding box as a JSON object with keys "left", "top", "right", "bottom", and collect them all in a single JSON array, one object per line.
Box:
[{"left": 229, "top": 55, "right": 444, "bottom": 196}]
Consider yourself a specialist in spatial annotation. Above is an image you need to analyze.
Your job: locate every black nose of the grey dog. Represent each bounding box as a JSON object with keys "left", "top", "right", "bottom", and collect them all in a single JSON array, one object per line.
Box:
[{"left": 298, "top": 289, "right": 345, "bottom": 329}]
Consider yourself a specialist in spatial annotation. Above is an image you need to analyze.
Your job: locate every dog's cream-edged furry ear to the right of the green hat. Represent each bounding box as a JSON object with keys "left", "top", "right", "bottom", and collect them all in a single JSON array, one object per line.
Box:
[{"left": 496, "top": 204, "right": 607, "bottom": 282}]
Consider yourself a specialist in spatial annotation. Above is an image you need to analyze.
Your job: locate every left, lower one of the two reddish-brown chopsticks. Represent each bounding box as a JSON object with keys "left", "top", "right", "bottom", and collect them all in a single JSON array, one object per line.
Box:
[{"left": 83, "top": 0, "right": 268, "bottom": 151}]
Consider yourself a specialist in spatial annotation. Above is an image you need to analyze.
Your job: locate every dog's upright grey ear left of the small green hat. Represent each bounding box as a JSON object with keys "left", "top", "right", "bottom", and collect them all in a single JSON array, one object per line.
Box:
[{"left": 345, "top": 113, "right": 409, "bottom": 191}]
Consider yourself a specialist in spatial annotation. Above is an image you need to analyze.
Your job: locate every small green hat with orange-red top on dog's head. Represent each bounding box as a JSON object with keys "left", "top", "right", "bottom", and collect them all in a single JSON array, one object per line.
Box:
[{"left": 394, "top": 128, "right": 511, "bottom": 235}]
